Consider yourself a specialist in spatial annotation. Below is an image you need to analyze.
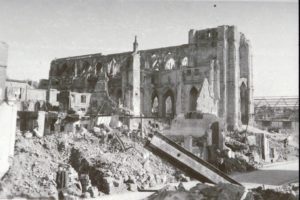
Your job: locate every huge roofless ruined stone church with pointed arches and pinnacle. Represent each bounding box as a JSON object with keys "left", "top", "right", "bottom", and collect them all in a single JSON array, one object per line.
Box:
[{"left": 49, "top": 26, "right": 253, "bottom": 129}]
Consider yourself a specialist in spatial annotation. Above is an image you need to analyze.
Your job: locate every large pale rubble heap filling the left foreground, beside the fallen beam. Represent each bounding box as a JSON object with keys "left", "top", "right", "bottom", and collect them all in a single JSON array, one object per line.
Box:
[{"left": 0, "top": 126, "right": 175, "bottom": 198}]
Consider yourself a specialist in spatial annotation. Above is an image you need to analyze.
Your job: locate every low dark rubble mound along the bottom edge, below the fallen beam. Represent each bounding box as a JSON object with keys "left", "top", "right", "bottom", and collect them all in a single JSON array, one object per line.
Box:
[{"left": 147, "top": 183, "right": 299, "bottom": 200}]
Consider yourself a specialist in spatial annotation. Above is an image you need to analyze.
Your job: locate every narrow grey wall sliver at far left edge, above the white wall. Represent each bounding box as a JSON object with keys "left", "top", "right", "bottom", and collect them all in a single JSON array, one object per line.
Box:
[{"left": 0, "top": 41, "right": 8, "bottom": 103}]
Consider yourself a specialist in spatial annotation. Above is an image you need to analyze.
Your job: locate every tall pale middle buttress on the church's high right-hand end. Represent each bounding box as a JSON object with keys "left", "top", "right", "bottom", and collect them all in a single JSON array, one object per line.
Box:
[{"left": 227, "top": 26, "right": 240, "bottom": 129}]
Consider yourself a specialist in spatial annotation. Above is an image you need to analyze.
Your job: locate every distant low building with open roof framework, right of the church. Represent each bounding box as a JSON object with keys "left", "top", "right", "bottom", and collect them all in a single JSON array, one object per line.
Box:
[{"left": 254, "top": 96, "right": 299, "bottom": 133}]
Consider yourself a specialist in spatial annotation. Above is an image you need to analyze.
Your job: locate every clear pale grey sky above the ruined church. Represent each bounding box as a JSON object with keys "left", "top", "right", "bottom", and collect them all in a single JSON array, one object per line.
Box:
[{"left": 0, "top": 0, "right": 299, "bottom": 96}]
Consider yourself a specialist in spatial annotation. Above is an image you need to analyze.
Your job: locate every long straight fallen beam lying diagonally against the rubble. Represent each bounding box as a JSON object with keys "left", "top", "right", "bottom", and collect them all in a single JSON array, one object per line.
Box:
[{"left": 145, "top": 133, "right": 241, "bottom": 185}]
